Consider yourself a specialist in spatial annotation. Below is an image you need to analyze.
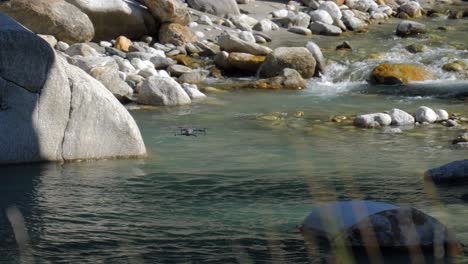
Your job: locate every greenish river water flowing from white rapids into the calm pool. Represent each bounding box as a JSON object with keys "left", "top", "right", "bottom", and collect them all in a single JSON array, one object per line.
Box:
[{"left": 0, "top": 20, "right": 468, "bottom": 263}]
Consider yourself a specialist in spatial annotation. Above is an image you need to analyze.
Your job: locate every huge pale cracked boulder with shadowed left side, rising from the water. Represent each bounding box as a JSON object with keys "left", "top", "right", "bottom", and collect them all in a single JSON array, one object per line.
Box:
[{"left": 0, "top": 14, "right": 146, "bottom": 164}]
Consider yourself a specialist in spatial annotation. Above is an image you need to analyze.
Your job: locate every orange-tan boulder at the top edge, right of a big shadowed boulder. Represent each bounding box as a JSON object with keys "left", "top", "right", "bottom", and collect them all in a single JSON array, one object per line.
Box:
[{"left": 143, "top": 0, "right": 191, "bottom": 26}]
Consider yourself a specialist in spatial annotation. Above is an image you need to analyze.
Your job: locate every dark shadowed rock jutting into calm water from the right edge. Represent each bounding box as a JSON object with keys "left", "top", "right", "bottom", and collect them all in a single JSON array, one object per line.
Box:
[{"left": 425, "top": 159, "right": 468, "bottom": 183}]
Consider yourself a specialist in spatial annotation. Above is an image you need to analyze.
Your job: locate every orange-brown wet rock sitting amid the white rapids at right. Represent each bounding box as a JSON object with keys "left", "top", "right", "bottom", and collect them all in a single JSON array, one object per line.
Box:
[{"left": 370, "top": 64, "right": 433, "bottom": 85}]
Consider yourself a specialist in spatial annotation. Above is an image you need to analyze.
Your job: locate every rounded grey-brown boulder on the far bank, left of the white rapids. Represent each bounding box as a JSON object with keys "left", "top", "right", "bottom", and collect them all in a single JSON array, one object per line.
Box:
[{"left": 258, "top": 47, "right": 316, "bottom": 78}]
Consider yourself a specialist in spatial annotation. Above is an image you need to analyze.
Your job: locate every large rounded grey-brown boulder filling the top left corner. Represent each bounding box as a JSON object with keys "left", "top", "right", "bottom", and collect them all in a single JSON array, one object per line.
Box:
[{"left": 0, "top": 0, "right": 94, "bottom": 44}]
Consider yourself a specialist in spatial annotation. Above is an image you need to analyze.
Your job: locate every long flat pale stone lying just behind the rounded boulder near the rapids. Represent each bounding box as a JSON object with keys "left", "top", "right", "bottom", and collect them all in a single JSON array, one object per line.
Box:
[{"left": 218, "top": 34, "right": 272, "bottom": 56}]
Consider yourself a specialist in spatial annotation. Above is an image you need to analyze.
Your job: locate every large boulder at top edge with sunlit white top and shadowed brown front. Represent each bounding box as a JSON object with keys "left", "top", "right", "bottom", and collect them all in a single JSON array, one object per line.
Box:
[{"left": 66, "top": 0, "right": 157, "bottom": 41}]
